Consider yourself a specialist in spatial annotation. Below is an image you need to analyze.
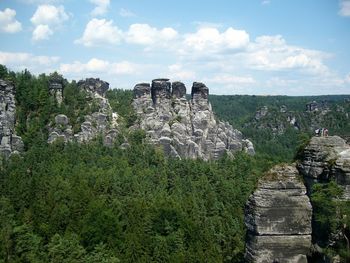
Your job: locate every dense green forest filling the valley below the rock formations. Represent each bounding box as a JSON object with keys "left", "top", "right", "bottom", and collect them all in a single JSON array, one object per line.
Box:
[{"left": 0, "top": 138, "right": 262, "bottom": 262}]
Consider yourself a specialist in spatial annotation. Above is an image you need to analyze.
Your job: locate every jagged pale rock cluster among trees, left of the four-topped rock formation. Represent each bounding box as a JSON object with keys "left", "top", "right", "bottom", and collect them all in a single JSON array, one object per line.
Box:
[{"left": 48, "top": 78, "right": 119, "bottom": 146}]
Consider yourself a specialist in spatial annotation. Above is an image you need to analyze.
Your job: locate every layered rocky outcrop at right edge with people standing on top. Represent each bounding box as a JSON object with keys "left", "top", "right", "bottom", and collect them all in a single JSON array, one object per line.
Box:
[{"left": 298, "top": 136, "right": 350, "bottom": 200}]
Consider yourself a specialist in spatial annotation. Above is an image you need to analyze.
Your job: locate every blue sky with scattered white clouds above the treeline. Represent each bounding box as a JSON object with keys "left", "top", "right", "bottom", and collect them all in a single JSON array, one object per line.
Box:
[{"left": 0, "top": 0, "right": 350, "bottom": 95}]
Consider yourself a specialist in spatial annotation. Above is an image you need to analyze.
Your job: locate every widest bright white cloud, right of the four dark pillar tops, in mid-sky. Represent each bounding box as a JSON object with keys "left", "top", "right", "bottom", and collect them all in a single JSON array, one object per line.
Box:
[{"left": 183, "top": 27, "right": 249, "bottom": 53}]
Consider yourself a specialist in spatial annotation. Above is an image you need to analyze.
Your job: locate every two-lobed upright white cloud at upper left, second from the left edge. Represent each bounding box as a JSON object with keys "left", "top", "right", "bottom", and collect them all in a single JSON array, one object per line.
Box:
[{"left": 30, "top": 5, "right": 69, "bottom": 41}]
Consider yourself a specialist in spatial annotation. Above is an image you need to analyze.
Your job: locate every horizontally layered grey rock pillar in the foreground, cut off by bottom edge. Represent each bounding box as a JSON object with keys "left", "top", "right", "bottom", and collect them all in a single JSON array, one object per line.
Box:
[{"left": 245, "top": 165, "right": 312, "bottom": 263}]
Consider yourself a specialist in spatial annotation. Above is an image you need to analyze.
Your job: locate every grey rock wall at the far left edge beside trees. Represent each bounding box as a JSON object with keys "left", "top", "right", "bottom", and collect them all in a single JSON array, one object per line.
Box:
[{"left": 0, "top": 79, "right": 24, "bottom": 157}]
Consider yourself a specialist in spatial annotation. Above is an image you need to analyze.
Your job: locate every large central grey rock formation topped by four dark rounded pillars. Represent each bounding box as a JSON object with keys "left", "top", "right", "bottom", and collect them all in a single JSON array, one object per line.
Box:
[{"left": 133, "top": 79, "right": 254, "bottom": 160}]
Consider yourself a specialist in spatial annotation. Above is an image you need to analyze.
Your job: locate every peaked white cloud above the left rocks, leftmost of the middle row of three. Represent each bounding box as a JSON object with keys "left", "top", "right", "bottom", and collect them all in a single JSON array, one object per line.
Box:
[{"left": 75, "top": 18, "right": 123, "bottom": 47}]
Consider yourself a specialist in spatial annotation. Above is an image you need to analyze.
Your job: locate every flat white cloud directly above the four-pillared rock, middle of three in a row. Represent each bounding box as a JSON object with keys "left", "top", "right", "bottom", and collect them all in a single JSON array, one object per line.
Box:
[{"left": 126, "top": 24, "right": 178, "bottom": 45}]
